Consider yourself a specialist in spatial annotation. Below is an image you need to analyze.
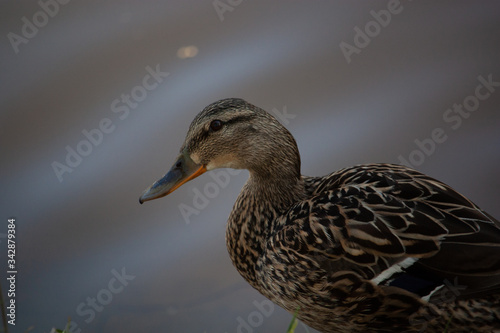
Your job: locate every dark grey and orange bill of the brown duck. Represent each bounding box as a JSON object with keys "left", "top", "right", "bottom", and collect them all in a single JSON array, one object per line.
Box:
[{"left": 139, "top": 152, "right": 207, "bottom": 204}]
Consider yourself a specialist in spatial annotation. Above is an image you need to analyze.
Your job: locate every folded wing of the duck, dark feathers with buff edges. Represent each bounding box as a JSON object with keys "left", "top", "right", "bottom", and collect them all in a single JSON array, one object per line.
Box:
[{"left": 267, "top": 164, "right": 500, "bottom": 301}]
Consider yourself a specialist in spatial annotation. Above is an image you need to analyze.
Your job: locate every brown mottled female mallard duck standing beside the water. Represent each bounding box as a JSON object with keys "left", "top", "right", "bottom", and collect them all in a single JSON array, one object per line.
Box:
[{"left": 140, "top": 99, "right": 500, "bottom": 332}]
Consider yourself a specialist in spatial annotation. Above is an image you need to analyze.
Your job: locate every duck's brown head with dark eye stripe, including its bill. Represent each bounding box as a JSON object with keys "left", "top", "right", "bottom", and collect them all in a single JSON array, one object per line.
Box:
[{"left": 139, "top": 98, "right": 300, "bottom": 204}]
